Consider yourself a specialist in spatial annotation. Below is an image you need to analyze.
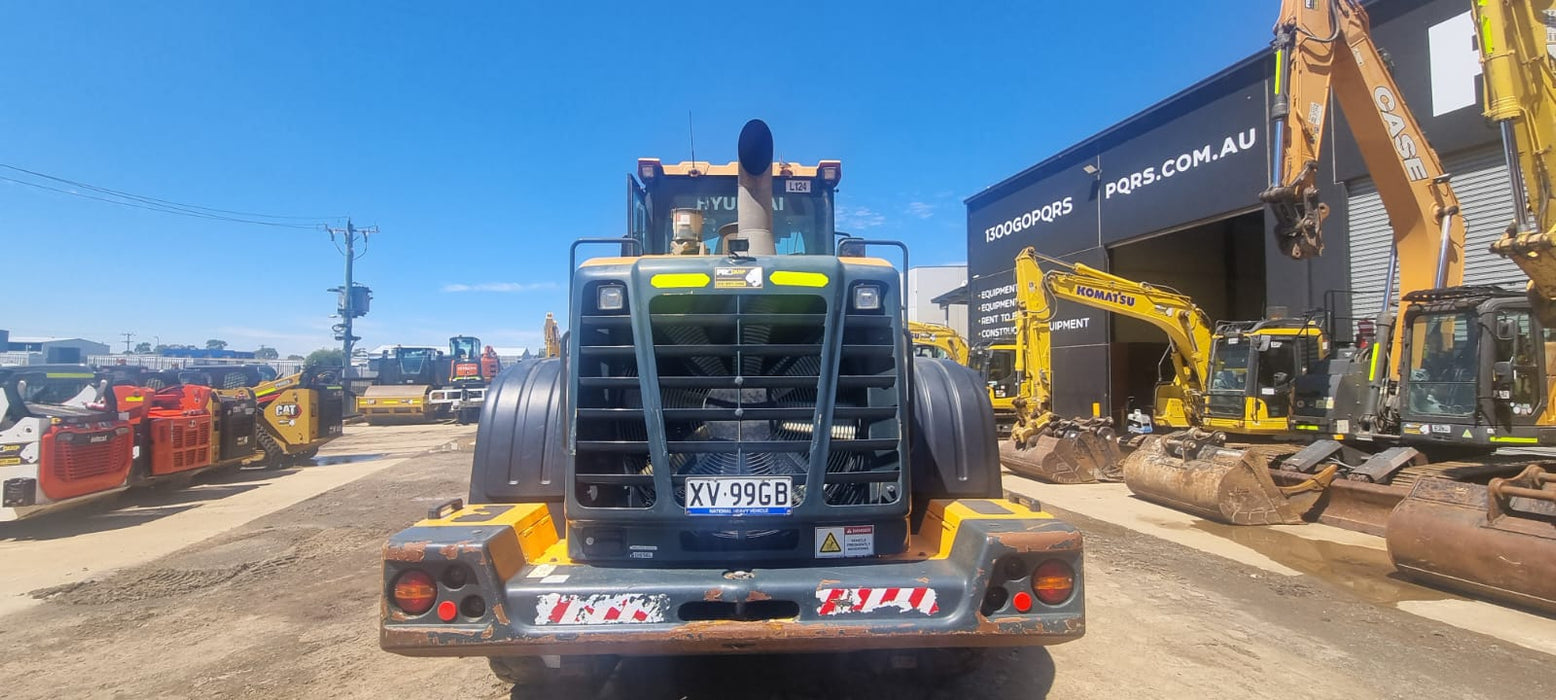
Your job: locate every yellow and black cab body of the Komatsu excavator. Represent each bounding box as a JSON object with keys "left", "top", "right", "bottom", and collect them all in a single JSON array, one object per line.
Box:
[{"left": 1203, "top": 319, "right": 1329, "bottom": 432}]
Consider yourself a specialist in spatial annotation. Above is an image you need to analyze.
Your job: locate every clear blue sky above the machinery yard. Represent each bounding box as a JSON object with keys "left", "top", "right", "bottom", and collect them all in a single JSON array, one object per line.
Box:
[{"left": 0, "top": 0, "right": 1277, "bottom": 353}]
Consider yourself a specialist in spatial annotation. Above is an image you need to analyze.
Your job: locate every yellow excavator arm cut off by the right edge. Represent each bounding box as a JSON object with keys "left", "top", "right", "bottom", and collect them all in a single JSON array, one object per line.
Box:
[{"left": 1474, "top": 0, "right": 1556, "bottom": 327}]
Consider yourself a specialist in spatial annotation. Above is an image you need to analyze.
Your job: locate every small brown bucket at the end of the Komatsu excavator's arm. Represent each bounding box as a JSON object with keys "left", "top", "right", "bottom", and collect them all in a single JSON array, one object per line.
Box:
[{"left": 999, "top": 418, "right": 1123, "bottom": 484}]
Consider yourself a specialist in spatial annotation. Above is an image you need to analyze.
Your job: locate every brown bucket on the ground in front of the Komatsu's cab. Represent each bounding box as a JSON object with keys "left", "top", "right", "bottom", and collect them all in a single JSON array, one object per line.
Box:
[{"left": 1123, "top": 431, "right": 1338, "bottom": 524}]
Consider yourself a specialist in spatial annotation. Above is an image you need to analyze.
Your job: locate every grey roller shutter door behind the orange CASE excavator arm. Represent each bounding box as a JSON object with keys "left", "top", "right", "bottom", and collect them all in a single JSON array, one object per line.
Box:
[{"left": 1346, "top": 148, "right": 1528, "bottom": 317}]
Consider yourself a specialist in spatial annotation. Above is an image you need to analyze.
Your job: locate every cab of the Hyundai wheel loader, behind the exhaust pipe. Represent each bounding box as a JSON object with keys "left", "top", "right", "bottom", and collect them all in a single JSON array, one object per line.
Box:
[{"left": 627, "top": 159, "right": 842, "bottom": 255}]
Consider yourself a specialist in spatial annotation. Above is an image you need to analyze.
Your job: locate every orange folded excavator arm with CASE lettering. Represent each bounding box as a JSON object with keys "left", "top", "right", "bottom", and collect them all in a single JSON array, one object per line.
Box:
[{"left": 1260, "top": 0, "right": 1464, "bottom": 378}]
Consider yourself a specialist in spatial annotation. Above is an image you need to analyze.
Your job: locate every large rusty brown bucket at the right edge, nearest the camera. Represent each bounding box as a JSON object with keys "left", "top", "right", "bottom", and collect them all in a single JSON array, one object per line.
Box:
[{"left": 1385, "top": 465, "right": 1556, "bottom": 614}]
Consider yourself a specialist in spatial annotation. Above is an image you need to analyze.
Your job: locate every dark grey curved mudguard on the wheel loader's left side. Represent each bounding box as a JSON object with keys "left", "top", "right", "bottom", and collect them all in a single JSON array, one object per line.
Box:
[{"left": 468, "top": 359, "right": 566, "bottom": 504}]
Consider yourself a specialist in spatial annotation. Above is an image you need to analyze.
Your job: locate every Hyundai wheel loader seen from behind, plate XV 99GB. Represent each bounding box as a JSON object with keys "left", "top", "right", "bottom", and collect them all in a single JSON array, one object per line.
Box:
[{"left": 381, "top": 121, "right": 1085, "bottom": 683}]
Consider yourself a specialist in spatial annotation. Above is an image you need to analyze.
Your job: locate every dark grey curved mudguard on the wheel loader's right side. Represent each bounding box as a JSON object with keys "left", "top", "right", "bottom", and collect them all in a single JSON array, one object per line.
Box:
[{"left": 910, "top": 358, "right": 1005, "bottom": 501}]
